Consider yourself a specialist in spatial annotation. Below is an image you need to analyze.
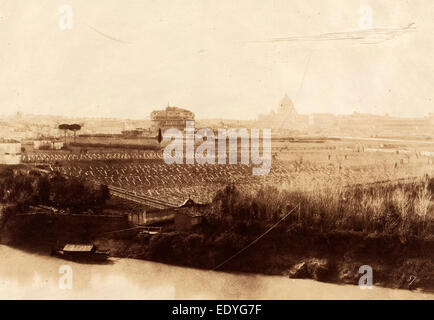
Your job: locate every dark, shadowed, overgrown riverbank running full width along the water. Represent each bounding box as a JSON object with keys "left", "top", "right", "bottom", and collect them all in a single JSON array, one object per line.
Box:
[{"left": 0, "top": 205, "right": 434, "bottom": 292}]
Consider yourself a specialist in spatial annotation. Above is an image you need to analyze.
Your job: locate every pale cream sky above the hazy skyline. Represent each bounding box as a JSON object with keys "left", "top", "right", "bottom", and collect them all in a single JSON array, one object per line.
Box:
[{"left": 0, "top": 0, "right": 434, "bottom": 119}]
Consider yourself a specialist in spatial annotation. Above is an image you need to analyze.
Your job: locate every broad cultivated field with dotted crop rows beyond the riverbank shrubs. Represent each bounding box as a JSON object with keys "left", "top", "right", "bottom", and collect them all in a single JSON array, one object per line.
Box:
[{"left": 24, "top": 140, "right": 434, "bottom": 208}]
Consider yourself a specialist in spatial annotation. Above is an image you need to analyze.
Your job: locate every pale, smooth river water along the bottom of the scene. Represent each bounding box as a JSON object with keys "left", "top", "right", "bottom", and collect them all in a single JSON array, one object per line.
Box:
[{"left": 0, "top": 245, "right": 434, "bottom": 299}]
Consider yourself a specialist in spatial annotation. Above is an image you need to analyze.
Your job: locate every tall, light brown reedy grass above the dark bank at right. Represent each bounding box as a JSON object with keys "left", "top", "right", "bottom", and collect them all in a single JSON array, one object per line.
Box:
[{"left": 215, "top": 176, "right": 434, "bottom": 239}]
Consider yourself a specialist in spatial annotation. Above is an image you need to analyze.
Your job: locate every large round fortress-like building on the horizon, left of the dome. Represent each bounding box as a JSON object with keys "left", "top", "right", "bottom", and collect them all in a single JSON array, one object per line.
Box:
[{"left": 151, "top": 106, "right": 194, "bottom": 133}]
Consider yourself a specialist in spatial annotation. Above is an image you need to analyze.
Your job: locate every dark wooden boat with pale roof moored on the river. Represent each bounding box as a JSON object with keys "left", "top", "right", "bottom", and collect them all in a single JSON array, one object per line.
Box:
[{"left": 51, "top": 243, "right": 110, "bottom": 262}]
